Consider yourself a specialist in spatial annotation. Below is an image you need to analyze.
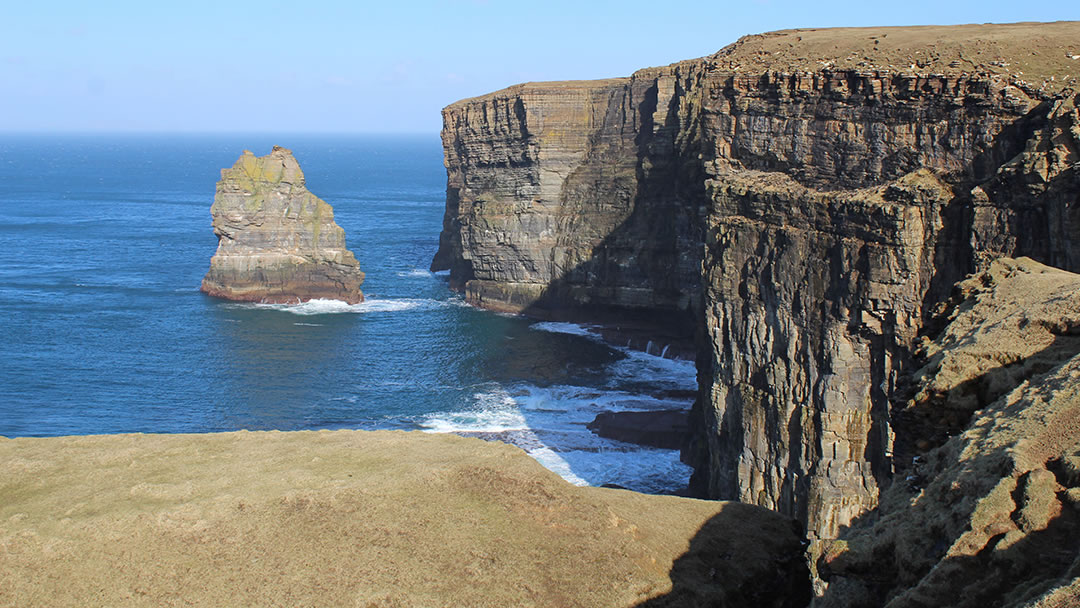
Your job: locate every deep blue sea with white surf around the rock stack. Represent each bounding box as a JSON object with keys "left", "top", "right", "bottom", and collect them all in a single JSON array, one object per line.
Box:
[{"left": 0, "top": 134, "right": 696, "bottom": 494}]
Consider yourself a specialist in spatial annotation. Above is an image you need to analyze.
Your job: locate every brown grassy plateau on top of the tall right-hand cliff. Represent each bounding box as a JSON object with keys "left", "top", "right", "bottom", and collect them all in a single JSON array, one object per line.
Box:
[{"left": 705, "top": 22, "right": 1080, "bottom": 92}]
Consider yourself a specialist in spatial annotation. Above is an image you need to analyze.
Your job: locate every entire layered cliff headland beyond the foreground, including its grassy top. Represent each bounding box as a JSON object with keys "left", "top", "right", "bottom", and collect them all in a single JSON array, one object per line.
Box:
[{"left": 433, "top": 23, "right": 1080, "bottom": 538}]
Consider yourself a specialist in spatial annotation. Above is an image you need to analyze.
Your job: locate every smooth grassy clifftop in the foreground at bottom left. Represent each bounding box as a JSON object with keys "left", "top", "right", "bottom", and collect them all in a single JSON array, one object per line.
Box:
[{"left": 0, "top": 431, "right": 809, "bottom": 608}]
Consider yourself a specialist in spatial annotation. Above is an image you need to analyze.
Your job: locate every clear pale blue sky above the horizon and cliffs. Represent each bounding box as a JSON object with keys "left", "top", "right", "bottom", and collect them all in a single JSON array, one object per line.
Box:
[{"left": 0, "top": 0, "right": 1080, "bottom": 133}]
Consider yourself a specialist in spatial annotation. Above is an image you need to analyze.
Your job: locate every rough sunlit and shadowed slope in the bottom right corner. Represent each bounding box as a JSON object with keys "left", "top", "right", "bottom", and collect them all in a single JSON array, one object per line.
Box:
[{"left": 814, "top": 259, "right": 1080, "bottom": 608}]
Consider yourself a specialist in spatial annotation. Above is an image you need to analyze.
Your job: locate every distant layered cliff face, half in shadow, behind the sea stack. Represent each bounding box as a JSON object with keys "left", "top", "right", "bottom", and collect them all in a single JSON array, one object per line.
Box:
[{"left": 432, "top": 65, "right": 703, "bottom": 330}]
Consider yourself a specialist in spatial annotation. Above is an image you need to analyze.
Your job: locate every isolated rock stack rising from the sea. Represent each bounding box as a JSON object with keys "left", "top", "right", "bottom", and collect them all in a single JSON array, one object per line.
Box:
[{"left": 202, "top": 146, "right": 364, "bottom": 303}]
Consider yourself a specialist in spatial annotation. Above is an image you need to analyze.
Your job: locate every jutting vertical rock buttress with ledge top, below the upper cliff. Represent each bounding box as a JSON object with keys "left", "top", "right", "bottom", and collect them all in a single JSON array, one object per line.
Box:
[{"left": 698, "top": 166, "right": 951, "bottom": 538}]
